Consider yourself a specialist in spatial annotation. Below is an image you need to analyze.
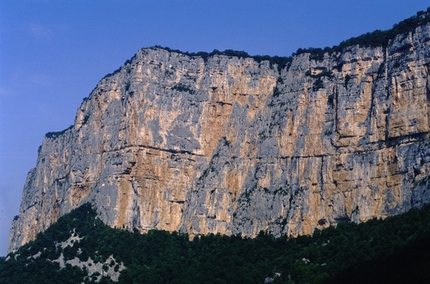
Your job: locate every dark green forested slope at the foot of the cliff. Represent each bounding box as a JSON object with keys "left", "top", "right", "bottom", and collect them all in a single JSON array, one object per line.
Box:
[{"left": 0, "top": 204, "right": 430, "bottom": 283}]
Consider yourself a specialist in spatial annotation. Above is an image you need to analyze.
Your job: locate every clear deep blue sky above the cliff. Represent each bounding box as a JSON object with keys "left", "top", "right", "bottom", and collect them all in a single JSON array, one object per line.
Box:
[{"left": 0, "top": 0, "right": 430, "bottom": 256}]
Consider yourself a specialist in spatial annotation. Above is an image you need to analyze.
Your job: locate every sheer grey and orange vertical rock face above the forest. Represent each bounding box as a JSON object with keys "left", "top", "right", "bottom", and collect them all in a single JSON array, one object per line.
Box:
[{"left": 9, "top": 20, "right": 430, "bottom": 251}]
